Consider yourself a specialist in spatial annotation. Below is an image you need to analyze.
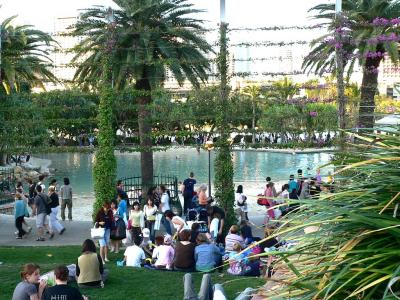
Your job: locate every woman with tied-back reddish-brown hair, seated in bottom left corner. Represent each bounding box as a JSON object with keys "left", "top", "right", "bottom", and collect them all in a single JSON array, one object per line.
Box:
[{"left": 12, "top": 263, "right": 47, "bottom": 300}]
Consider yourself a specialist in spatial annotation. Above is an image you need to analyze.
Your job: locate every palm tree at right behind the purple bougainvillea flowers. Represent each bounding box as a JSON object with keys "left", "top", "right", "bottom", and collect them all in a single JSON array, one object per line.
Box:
[{"left": 303, "top": 0, "right": 400, "bottom": 128}]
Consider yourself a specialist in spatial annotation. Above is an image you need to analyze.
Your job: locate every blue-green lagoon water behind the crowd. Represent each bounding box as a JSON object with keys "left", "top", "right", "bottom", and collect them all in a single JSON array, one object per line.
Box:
[{"left": 38, "top": 148, "right": 332, "bottom": 219}]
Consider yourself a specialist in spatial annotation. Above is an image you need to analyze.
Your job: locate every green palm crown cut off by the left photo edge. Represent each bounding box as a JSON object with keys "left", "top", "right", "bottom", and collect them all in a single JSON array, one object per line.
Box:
[{"left": 0, "top": 16, "right": 57, "bottom": 94}]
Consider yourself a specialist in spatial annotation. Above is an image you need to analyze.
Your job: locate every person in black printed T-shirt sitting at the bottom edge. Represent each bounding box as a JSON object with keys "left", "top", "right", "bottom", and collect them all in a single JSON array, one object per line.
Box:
[{"left": 41, "top": 265, "right": 88, "bottom": 300}]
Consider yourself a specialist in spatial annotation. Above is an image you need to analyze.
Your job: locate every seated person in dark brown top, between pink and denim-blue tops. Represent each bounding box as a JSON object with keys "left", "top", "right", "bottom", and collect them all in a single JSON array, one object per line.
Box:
[{"left": 174, "top": 229, "right": 196, "bottom": 272}]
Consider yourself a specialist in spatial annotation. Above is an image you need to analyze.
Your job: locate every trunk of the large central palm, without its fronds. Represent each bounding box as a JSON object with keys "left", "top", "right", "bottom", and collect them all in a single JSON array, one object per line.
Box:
[{"left": 136, "top": 78, "right": 153, "bottom": 192}]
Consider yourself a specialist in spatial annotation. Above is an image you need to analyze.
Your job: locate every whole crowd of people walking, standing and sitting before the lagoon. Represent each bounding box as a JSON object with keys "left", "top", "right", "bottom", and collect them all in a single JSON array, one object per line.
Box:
[{"left": 13, "top": 170, "right": 334, "bottom": 299}]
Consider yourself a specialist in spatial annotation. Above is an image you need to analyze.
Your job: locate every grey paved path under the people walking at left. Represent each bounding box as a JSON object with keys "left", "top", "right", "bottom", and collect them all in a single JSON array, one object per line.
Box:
[{"left": 0, "top": 214, "right": 263, "bottom": 247}]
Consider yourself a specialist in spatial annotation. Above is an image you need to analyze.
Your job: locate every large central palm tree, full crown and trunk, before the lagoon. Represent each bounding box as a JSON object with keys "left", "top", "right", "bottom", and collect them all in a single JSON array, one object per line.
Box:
[{"left": 74, "top": 0, "right": 211, "bottom": 183}]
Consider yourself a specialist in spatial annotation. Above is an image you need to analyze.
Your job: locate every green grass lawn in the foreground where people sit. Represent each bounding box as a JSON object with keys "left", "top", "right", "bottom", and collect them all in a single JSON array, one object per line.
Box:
[{"left": 0, "top": 246, "right": 265, "bottom": 300}]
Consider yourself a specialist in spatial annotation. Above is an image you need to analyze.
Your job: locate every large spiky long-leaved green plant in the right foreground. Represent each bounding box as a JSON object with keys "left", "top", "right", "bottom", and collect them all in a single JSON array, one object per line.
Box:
[{"left": 260, "top": 130, "right": 400, "bottom": 299}]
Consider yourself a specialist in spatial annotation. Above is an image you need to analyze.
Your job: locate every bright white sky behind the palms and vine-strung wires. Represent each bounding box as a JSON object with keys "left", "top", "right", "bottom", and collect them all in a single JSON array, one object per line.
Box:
[{"left": 0, "top": 0, "right": 335, "bottom": 81}]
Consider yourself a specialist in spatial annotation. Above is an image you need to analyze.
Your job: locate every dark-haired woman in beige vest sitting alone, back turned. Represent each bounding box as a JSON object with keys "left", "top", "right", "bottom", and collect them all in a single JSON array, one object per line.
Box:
[{"left": 76, "top": 239, "right": 108, "bottom": 288}]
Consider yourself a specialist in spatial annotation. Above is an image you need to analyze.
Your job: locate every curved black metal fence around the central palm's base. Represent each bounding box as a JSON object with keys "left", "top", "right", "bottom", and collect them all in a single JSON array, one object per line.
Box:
[{"left": 120, "top": 175, "right": 182, "bottom": 215}]
